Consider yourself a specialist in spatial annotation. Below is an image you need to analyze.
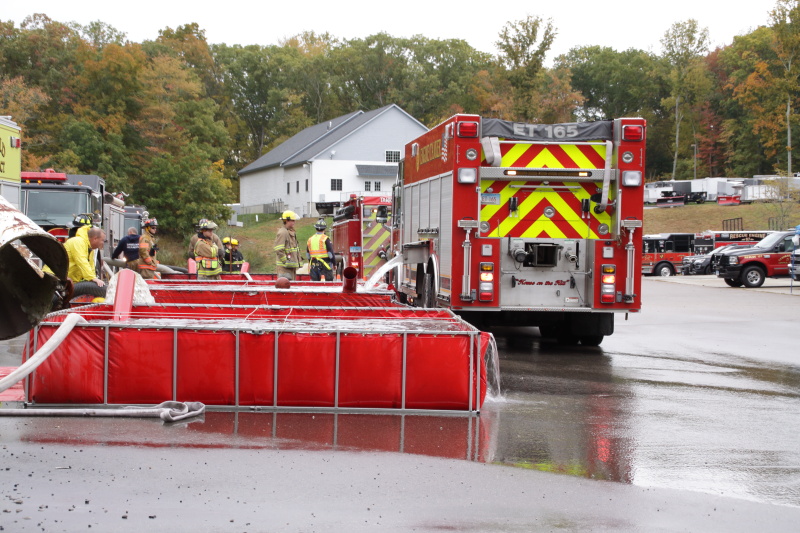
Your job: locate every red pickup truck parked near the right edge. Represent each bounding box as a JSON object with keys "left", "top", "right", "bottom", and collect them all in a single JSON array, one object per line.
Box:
[{"left": 711, "top": 230, "right": 795, "bottom": 288}]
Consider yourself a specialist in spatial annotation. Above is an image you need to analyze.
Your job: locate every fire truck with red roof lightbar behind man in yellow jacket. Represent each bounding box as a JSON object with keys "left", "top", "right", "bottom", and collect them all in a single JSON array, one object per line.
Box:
[{"left": 20, "top": 169, "right": 125, "bottom": 257}]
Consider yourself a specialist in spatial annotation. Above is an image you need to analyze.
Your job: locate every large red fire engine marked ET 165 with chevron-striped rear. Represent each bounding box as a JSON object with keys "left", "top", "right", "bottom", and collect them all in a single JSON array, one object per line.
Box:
[{"left": 392, "top": 114, "right": 646, "bottom": 346}]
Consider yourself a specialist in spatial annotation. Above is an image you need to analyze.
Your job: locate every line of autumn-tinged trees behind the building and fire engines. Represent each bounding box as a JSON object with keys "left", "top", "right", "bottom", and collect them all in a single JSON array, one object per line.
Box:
[{"left": 0, "top": 0, "right": 800, "bottom": 233}]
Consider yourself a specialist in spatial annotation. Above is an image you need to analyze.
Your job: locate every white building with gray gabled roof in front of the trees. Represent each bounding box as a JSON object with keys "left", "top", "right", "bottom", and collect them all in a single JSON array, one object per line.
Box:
[{"left": 239, "top": 104, "right": 428, "bottom": 217}]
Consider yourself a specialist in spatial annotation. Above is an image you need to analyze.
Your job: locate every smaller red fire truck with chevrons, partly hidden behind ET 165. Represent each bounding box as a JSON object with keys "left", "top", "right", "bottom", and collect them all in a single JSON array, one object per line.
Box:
[{"left": 331, "top": 194, "right": 392, "bottom": 279}]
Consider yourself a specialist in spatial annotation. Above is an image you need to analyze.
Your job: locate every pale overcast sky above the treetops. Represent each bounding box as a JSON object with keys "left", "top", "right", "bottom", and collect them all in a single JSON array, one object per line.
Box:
[{"left": 0, "top": 0, "right": 775, "bottom": 59}]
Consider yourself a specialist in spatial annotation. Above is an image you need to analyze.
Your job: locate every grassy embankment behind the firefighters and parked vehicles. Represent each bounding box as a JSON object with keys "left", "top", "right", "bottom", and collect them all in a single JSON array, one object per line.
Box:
[{"left": 153, "top": 203, "right": 800, "bottom": 273}]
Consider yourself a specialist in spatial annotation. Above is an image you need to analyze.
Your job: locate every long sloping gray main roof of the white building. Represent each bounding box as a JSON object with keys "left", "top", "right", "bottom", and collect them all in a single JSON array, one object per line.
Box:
[{"left": 239, "top": 104, "right": 412, "bottom": 176}]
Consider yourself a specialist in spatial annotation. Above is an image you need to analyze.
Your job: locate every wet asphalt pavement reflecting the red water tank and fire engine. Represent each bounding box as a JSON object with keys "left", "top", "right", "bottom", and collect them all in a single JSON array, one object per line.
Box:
[{"left": 0, "top": 276, "right": 800, "bottom": 532}]
